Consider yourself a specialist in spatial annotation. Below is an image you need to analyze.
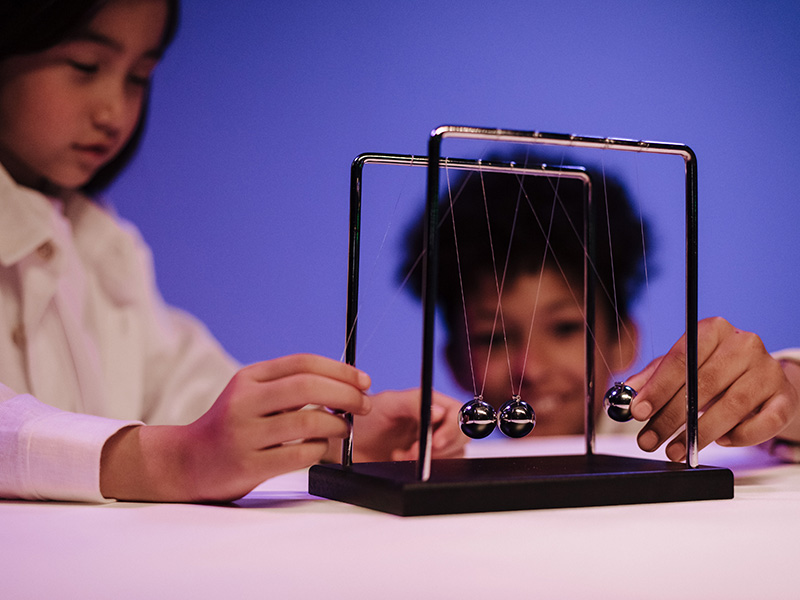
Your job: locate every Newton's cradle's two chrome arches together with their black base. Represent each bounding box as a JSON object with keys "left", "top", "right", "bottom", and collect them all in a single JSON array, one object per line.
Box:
[{"left": 309, "top": 125, "right": 733, "bottom": 516}]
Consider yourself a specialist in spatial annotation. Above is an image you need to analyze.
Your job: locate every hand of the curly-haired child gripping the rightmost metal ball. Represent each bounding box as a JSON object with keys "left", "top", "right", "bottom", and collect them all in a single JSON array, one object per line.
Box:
[{"left": 626, "top": 317, "right": 800, "bottom": 461}]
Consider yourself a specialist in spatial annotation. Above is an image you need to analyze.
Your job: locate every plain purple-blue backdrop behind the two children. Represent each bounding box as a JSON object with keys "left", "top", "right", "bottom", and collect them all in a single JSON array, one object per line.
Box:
[{"left": 109, "top": 0, "right": 800, "bottom": 398}]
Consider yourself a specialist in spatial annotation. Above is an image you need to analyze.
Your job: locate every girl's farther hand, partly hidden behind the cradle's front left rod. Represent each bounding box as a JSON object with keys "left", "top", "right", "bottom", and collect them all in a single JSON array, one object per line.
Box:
[{"left": 353, "top": 389, "right": 469, "bottom": 462}]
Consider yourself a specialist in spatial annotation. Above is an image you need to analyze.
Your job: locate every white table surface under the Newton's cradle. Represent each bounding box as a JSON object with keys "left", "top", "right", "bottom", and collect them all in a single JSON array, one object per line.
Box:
[{"left": 0, "top": 437, "right": 800, "bottom": 600}]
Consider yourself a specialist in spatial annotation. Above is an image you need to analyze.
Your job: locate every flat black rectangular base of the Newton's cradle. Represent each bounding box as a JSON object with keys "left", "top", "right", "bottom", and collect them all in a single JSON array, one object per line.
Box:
[{"left": 308, "top": 454, "right": 733, "bottom": 516}]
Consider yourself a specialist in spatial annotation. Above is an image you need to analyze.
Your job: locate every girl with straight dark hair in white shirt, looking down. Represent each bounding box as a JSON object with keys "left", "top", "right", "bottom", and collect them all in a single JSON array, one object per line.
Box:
[{"left": 0, "top": 0, "right": 464, "bottom": 501}]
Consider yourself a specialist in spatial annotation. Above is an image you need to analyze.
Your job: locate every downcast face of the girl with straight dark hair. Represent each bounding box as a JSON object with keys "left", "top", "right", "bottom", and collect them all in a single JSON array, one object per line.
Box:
[{"left": 0, "top": 0, "right": 167, "bottom": 189}]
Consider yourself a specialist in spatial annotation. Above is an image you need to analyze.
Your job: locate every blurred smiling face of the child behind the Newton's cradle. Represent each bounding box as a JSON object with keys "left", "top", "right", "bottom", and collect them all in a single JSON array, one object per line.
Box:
[{"left": 450, "top": 268, "right": 635, "bottom": 435}]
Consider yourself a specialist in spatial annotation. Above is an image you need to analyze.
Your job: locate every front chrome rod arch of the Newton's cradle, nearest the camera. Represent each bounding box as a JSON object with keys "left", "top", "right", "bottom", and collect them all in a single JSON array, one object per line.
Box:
[{"left": 420, "top": 125, "right": 699, "bottom": 474}]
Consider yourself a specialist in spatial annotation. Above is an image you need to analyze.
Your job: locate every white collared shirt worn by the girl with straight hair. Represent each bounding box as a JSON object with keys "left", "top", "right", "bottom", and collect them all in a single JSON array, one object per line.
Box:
[{"left": 0, "top": 166, "right": 237, "bottom": 501}]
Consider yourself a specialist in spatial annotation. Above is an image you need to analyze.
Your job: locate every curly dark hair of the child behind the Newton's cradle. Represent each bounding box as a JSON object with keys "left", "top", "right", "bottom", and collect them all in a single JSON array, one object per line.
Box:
[{"left": 398, "top": 152, "right": 651, "bottom": 334}]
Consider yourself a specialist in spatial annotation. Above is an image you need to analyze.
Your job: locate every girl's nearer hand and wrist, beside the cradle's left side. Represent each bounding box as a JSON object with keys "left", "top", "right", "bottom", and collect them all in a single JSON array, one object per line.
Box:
[{"left": 100, "top": 355, "right": 371, "bottom": 502}]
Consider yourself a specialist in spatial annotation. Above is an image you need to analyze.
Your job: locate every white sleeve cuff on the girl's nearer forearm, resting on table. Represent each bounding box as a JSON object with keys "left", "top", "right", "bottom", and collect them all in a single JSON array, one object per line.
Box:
[{"left": 0, "top": 384, "right": 139, "bottom": 502}]
